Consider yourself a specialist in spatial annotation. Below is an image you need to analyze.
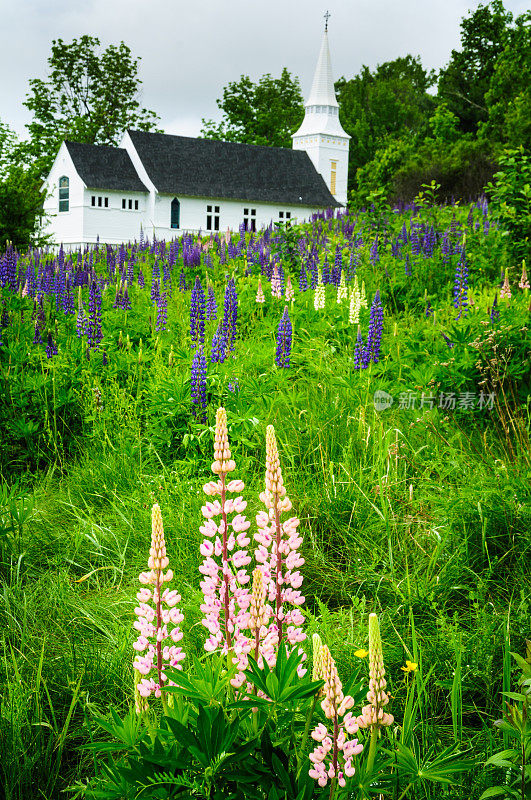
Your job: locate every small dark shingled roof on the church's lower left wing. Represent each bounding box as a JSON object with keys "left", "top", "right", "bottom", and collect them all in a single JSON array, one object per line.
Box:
[{"left": 65, "top": 142, "right": 148, "bottom": 192}]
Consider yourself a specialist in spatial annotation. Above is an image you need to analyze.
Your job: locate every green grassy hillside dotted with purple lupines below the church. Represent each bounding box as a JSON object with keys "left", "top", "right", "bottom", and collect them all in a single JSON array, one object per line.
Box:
[{"left": 0, "top": 203, "right": 531, "bottom": 800}]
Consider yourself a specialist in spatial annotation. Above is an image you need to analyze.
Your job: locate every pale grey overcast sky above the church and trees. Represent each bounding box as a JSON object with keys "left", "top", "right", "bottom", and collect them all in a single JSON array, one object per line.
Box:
[{"left": 0, "top": 0, "right": 528, "bottom": 141}]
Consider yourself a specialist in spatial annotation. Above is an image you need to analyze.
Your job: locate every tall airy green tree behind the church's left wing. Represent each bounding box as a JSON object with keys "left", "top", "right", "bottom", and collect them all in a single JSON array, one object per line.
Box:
[{"left": 23, "top": 35, "right": 158, "bottom": 177}]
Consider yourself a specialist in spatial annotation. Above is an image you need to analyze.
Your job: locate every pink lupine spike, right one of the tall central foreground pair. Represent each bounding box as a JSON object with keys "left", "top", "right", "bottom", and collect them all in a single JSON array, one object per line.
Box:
[{"left": 254, "top": 425, "right": 306, "bottom": 676}]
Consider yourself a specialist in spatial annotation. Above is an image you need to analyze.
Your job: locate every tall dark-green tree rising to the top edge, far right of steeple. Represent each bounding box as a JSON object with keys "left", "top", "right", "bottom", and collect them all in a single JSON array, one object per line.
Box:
[{"left": 438, "top": 0, "right": 513, "bottom": 133}]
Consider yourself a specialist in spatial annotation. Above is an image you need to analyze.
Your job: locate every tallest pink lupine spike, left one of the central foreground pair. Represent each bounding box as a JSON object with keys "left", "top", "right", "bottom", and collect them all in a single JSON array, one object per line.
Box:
[{"left": 199, "top": 408, "right": 252, "bottom": 687}]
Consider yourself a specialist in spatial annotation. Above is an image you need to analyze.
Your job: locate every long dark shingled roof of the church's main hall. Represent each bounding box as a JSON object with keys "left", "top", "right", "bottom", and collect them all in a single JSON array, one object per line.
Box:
[{"left": 128, "top": 131, "right": 340, "bottom": 208}]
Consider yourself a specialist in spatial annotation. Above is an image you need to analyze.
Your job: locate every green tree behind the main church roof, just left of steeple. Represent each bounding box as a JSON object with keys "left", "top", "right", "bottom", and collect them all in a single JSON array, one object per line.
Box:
[{"left": 201, "top": 67, "right": 304, "bottom": 147}]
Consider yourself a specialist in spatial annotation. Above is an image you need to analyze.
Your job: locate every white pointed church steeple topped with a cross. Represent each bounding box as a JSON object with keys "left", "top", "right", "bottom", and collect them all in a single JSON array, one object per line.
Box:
[{"left": 293, "top": 11, "right": 350, "bottom": 204}]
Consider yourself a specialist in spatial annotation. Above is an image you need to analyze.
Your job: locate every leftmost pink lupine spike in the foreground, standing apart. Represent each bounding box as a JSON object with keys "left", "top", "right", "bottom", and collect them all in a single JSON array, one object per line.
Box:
[{"left": 133, "top": 503, "right": 185, "bottom": 713}]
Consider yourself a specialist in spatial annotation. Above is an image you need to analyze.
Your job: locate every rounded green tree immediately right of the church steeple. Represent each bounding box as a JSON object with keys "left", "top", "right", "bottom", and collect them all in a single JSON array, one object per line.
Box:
[{"left": 335, "top": 55, "right": 436, "bottom": 189}]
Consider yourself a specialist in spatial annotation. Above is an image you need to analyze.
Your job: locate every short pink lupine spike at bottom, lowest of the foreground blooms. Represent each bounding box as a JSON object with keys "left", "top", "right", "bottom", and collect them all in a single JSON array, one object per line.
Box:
[{"left": 309, "top": 645, "right": 363, "bottom": 796}]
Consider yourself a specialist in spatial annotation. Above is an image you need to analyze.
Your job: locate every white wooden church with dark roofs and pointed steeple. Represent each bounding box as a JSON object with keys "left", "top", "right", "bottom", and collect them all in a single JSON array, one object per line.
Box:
[{"left": 43, "top": 27, "right": 350, "bottom": 248}]
